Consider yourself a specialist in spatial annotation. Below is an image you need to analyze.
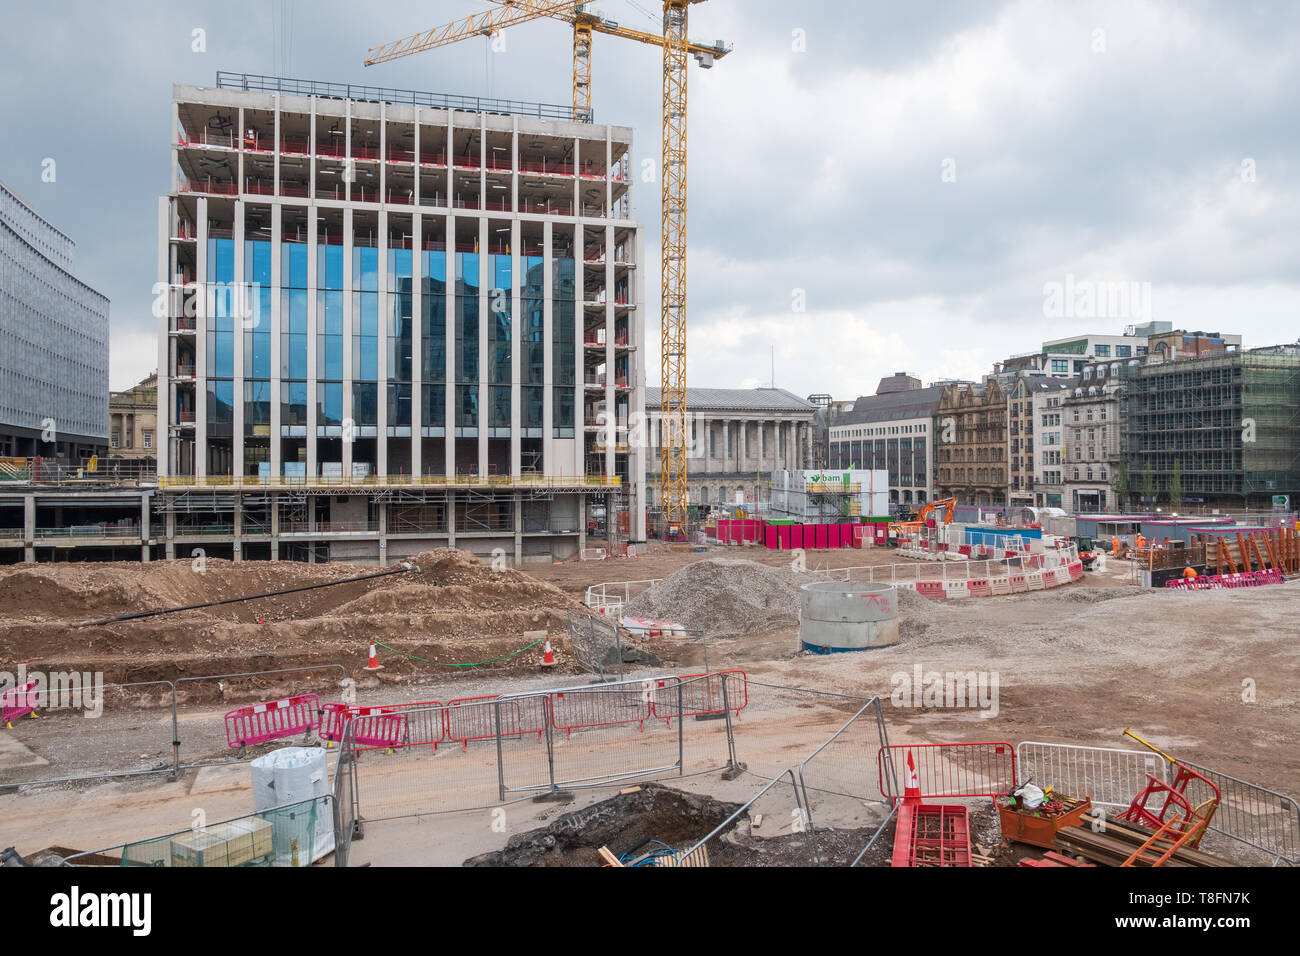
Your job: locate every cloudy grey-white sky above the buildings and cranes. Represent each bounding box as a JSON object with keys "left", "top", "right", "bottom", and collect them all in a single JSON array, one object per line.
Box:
[{"left": 0, "top": 0, "right": 1300, "bottom": 398}]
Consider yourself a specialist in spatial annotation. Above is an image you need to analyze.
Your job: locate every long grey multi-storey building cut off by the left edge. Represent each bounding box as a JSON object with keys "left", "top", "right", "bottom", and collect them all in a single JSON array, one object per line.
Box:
[{"left": 0, "top": 183, "right": 108, "bottom": 464}]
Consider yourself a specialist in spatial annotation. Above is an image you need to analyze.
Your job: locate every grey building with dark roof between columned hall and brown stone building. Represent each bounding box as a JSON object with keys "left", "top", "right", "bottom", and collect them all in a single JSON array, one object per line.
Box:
[{"left": 829, "top": 372, "right": 944, "bottom": 507}]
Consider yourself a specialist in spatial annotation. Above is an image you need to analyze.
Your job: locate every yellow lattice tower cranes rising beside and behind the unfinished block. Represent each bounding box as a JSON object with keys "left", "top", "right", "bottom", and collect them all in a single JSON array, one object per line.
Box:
[{"left": 365, "top": 0, "right": 732, "bottom": 528}]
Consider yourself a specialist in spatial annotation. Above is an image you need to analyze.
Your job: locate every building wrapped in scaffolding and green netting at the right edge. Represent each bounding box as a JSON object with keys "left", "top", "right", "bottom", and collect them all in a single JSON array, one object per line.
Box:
[{"left": 1121, "top": 345, "right": 1300, "bottom": 510}]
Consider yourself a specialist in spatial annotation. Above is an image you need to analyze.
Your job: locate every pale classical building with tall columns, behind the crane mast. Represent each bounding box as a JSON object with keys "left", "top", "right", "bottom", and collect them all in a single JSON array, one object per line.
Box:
[{"left": 645, "top": 388, "right": 816, "bottom": 509}]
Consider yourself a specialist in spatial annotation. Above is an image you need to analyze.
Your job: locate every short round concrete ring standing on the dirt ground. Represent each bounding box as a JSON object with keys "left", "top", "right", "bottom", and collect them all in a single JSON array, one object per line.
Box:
[{"left": 800, "top": 581, "right": 898, "bottom": 654}]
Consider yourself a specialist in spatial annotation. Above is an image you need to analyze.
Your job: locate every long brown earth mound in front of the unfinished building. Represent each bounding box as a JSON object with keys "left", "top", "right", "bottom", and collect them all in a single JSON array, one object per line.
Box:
[{"left": 0, "top": 549, "right": 575, "bottom": 682}]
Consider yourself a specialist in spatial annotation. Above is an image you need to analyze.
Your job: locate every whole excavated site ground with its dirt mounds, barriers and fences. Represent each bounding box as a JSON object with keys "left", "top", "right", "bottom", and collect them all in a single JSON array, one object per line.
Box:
[{"left": 0, "top": 502, "right": 1300, "bottom": 866}]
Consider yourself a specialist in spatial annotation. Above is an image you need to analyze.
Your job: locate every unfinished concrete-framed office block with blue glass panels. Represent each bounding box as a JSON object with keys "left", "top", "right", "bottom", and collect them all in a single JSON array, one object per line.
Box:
[{"left": 157, "top": 74, "right": 646, "bottom": 563}]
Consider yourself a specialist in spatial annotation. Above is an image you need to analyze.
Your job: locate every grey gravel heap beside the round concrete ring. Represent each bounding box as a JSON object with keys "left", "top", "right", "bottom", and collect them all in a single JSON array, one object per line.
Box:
[{"left": 624, "top": 558, "right": 810, "bottom": 637}]
